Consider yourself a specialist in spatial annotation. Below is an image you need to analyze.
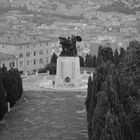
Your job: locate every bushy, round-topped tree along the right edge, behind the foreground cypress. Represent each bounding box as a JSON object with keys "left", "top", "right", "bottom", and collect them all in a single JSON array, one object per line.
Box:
[{"left": 119, "top": 41, "right": 140, "bottom": 139}]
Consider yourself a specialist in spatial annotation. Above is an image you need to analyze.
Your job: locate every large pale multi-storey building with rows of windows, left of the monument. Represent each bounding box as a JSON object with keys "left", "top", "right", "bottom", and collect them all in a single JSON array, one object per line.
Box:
[{"left": 0, "top": 38, "right": 51, "bottom": 73}]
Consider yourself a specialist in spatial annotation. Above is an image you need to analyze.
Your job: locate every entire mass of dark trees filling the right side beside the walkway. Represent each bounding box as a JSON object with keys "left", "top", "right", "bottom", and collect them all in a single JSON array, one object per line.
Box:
[{"left": 86, "top": 41, "right": 140, "bottom": 140}]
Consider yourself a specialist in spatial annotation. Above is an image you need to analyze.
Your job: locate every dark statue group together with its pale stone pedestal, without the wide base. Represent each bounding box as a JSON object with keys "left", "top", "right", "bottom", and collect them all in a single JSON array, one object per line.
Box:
[{"left": 55, "top": 35, "right": 82, "bottom": 88}]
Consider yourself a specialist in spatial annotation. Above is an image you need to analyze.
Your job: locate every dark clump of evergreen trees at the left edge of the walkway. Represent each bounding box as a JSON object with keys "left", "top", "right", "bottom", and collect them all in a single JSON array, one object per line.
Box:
[{"left": 0, "top": 68, "right": 23, "bottom": 120}]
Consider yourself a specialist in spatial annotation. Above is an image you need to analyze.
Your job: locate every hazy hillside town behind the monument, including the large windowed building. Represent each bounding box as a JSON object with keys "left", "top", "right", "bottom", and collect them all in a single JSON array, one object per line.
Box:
[{"left": 0, "top": 0, "right": 140, "bottom": 72}]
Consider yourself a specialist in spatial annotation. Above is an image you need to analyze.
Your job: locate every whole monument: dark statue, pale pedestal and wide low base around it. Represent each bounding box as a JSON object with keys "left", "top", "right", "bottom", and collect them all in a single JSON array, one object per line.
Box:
[{"left": 39, "top": 35, "right": 89, "bottom": 92}]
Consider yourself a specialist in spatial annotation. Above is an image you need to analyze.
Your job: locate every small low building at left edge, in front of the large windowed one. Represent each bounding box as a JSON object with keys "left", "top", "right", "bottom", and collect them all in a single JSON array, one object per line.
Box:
[{"left": 0, "top": 52, "right": 17, "bottom": 70}]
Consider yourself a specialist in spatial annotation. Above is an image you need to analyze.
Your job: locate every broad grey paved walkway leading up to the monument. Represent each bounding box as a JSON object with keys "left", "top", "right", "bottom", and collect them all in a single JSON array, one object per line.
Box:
[{"left": 0, "top": 76, "right": 88, "bottom": 140}]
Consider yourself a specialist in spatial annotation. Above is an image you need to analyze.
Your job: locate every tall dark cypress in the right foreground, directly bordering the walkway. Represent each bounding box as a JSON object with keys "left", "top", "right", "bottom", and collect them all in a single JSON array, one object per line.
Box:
[{"left": 86, "top": 62, "right": 133, "bottom": 140}]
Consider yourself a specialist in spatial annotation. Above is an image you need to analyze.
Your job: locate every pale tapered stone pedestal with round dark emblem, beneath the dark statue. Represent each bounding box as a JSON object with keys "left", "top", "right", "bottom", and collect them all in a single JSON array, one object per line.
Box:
[{"left": 55, "top": 56, "right": 82, "bottom": 87}]
